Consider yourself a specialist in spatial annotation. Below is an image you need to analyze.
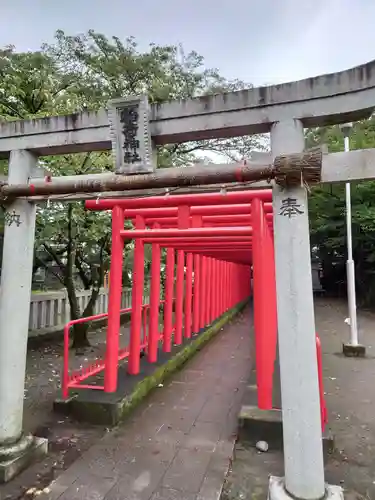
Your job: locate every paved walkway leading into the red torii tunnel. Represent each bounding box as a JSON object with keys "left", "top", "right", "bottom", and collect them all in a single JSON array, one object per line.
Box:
[{"left": 39, "top": 309, "right": 251, "bottom": 500}]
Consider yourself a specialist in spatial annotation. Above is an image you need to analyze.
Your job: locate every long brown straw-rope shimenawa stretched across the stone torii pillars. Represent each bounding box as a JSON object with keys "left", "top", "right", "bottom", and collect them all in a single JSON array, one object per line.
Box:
[{"left": 0, "top": 148, "right": 322, "bottom": 202}]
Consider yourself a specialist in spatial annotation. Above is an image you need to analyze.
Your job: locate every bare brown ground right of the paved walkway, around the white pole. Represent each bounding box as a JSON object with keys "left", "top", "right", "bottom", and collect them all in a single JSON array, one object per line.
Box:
[{"left": 222, "top": 298, "right": 375, "bottom": 500}]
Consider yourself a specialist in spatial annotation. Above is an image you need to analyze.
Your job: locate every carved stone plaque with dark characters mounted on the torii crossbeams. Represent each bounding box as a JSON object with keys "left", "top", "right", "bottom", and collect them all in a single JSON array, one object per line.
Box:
[{"left": 108, "top": 96, "right": 155, "bottom": 174}]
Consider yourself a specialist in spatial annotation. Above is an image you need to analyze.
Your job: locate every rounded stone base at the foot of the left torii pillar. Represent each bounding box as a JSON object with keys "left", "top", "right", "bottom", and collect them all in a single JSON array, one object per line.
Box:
[{"left": 0, "top": 435, "right": 48, "bottom": 484}]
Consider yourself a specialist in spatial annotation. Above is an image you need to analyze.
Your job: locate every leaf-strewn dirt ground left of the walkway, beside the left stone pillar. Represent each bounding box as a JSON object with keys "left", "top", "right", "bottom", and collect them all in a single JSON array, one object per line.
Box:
[{"left": 0, "top": 326, "right": 129, "bottom": 500}]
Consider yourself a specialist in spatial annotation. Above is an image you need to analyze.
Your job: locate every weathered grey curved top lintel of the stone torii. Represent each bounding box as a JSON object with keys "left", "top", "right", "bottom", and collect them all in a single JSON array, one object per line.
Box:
[{"left": 0, "top": 61, "right": 375, "bottom": 156}]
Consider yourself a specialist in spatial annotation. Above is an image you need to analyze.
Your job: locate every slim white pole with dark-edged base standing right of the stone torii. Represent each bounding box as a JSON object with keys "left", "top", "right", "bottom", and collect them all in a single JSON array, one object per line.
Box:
[{"left": 340, "top": 123, "right": 365, "bottom": 357}]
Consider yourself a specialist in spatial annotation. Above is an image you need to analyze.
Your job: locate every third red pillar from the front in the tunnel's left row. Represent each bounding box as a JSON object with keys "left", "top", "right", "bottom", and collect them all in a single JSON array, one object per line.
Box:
[{"left": 147, "top": 223, "right": 161, "bottom": 363}]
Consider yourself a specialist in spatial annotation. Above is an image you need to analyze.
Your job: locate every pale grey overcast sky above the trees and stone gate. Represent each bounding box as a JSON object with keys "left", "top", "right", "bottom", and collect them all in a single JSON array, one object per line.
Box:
[{"left": 0, "top": 0, "right": 375, "bottom": 85}]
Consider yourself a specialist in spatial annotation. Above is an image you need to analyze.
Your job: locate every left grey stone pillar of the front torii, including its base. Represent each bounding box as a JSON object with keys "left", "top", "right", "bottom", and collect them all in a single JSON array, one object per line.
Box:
[{"left": 0, "top": 150, "right": 47, "bottom": 482}]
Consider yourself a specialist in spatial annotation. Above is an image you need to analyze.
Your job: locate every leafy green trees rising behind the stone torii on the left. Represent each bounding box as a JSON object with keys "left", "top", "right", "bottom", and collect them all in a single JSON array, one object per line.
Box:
[{"left": 0, "top": 30, "right": 262, "bottom": 346}]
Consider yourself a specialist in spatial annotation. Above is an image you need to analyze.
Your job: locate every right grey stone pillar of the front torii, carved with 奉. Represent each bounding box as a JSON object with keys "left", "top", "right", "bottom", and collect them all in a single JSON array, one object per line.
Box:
[{"left": 269, "top": 120, "right": 341, "bottom": 500}]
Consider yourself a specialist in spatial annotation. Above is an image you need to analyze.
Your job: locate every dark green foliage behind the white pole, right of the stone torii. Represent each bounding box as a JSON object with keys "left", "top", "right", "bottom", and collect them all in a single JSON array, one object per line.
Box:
[{"left": 307, "top": 117, "right": 375, "bottom": 306}]
